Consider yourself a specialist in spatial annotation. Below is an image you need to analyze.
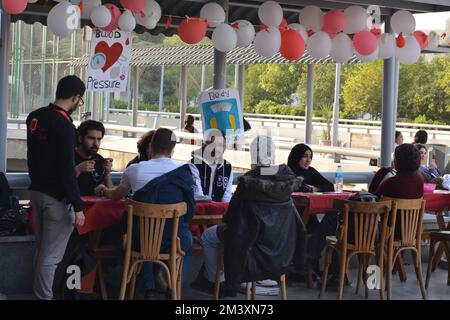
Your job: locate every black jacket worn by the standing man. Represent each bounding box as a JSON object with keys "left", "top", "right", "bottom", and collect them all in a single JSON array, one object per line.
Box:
[{"left": 27, "top": 104, "right": 83, "bottom": 212}]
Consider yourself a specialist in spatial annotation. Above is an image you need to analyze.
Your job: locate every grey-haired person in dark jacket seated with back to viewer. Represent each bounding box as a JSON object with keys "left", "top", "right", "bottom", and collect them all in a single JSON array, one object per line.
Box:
[{"left": 190, "top": 136, "right": 305, "bottom": 296}]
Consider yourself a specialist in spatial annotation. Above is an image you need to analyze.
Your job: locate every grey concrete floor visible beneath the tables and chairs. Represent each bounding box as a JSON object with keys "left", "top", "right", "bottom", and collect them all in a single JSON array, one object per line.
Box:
[{"left": 5, "top": 257, "right": 450, "bottom": 300}]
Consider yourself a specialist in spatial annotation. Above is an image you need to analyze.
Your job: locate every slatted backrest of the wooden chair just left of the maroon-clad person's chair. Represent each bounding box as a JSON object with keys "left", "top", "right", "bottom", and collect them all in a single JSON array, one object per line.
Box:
[{"left": 335, "top": 200, "right": 391, "bottom": 252}]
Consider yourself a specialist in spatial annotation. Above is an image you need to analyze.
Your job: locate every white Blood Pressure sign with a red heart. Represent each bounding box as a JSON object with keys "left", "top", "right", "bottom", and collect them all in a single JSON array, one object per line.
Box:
[{"left": 86, "top": 29, "right": 132, "bottom": 92}]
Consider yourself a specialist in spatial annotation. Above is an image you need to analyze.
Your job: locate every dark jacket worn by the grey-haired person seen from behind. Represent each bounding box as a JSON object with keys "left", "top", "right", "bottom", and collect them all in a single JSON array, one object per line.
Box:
[{"left": 223, "top": 165, "right": 304, "bottom": 291}]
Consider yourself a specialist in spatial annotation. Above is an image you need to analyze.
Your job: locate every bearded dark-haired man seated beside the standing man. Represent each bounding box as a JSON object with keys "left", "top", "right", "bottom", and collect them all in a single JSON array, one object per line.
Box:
[{"left": 75, "top": 120, "right": 113, "bottom": 196}]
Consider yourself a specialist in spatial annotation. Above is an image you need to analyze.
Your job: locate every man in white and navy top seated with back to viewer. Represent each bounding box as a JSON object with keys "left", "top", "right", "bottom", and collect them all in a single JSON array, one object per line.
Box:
[{"left": 96, "top": 128, "right": 195, "bottom": 298}]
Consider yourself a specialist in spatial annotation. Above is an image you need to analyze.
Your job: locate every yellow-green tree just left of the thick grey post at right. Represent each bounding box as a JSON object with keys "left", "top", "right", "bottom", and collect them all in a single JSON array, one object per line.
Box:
[{"left": 342, "top": 59, "right": 383, "bottom": 119}]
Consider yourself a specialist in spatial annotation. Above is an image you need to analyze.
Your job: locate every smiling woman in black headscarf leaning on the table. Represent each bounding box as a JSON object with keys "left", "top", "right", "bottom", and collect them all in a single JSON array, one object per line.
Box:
[{"left": 288, "top": 143, "right": 334, "bottom": 192}]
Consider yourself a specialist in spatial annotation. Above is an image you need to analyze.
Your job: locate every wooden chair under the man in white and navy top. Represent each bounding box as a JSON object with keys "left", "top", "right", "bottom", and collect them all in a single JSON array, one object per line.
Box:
[{"left": 119, "top": 200, "right": 187, "bottom": 300}]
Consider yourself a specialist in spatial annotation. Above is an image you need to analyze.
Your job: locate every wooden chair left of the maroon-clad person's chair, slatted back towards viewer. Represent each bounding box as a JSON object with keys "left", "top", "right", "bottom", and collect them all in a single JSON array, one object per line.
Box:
[{"left": 319, "top": 200, "right": 391, "bottom": 300}]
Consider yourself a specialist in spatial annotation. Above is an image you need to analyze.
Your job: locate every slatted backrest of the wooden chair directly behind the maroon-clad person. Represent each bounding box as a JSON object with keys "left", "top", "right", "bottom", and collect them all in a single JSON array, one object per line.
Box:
[{"left": 381, "top": 196, "right": 425, "bottom": 247}]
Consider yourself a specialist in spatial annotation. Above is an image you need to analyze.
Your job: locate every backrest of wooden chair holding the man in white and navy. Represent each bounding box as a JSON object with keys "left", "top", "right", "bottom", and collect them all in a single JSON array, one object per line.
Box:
[{"left": 127, "top": 200, "right": 187, "bottom": 260}]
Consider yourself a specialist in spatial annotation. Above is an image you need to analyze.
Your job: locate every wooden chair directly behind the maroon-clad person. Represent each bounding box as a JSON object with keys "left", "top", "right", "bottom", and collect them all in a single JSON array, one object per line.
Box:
[{"left": 381, "top": 196, "right": 427, "bottom": 300}]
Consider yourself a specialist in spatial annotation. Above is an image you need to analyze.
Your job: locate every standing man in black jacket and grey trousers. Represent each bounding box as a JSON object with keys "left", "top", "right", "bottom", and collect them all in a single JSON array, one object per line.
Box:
[{"left": 27, "top": 76, "right": 86, "bottom": 300}]
